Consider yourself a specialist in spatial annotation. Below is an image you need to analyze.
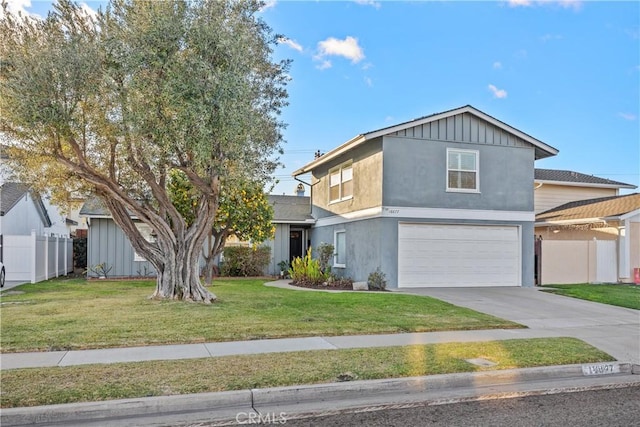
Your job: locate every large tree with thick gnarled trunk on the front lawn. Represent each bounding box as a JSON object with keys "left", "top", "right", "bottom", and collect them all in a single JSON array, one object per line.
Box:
[{"left": 0, "top": 0, "right": 289, "bottom": 302}]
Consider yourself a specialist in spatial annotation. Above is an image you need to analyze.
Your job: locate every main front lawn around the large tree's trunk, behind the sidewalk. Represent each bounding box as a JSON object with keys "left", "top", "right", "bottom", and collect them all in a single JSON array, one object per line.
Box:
[{"left": 0, "top": 279, "right": 522, "bottom": 352}]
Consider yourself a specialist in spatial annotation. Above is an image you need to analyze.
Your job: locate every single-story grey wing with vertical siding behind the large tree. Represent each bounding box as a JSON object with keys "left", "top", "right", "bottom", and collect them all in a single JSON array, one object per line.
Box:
[{"left": 80, "top": 195, "right": 314, "bottom": 277}]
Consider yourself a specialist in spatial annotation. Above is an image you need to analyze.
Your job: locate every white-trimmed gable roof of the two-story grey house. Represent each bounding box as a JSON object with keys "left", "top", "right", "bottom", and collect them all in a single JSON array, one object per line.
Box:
[{"left": 292, "top": 105, "right": 558, "bottom": 176}]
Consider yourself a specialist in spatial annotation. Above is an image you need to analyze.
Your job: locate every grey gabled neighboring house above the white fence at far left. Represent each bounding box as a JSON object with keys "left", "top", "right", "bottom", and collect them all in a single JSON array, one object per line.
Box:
[{"left": 0, "top": 182, "right": 51, "bottom": 236}]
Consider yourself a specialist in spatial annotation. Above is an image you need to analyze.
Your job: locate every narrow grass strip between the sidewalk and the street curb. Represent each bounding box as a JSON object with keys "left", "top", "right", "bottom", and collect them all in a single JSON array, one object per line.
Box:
[{"left": 0, "top": 338, "right": 614, "bottom": 408}]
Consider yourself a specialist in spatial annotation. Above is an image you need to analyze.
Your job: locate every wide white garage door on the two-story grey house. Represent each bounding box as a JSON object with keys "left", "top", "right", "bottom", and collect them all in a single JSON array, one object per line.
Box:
[{"left": 398, "top": 224, "right": 521, "bottom": 288}]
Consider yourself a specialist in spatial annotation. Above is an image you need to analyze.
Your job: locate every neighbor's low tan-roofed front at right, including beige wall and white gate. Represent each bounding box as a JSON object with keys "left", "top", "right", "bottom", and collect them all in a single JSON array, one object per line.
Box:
[{"left": 535, "top": 193, "right": 640, "bottom": 284}]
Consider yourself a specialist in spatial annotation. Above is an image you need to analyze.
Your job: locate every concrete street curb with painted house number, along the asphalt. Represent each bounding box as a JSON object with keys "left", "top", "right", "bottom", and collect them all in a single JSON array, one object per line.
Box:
[{"left": 0, "top": 362, "right": 640, "bottom": 427}]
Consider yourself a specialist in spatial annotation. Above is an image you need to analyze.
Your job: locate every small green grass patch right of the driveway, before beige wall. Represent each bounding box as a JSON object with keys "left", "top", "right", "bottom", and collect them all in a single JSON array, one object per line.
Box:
[{"left": 545, "top": 284, "right": 640, "bottom": 310}]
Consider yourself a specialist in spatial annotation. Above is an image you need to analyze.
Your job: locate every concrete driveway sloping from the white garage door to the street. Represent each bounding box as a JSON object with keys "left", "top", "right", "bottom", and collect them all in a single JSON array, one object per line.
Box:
[{"left": 399, "top": 287, "right": 640, "bottom": 364}]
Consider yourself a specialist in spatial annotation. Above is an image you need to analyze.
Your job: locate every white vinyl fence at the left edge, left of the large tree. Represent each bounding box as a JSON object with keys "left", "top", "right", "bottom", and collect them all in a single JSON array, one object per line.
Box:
[{"left": 2, "top": 232, "right": 73, "bottom": 283}]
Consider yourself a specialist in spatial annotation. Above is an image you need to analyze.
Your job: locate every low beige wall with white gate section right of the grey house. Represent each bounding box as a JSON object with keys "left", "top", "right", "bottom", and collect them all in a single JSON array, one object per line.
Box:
[{"left": 541, "top": 240, "right": 618, "bottom": 285}]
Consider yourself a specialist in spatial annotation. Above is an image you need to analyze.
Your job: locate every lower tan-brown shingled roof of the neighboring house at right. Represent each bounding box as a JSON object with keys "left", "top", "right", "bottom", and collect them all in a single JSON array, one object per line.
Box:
[{"left": 536, "top": 193, "right": 640, "bottom": 225}]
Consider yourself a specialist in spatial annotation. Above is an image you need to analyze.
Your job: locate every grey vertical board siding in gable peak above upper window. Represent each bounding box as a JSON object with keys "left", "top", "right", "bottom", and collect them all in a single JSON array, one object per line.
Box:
[{"left": 393, "top": 113, "right": 529, "bottom": 147}]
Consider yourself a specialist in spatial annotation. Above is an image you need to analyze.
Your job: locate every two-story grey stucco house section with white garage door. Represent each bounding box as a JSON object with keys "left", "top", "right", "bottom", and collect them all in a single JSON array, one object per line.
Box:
[{"left": 293, "top": 106, "right": 558, "bottom": 288}]
